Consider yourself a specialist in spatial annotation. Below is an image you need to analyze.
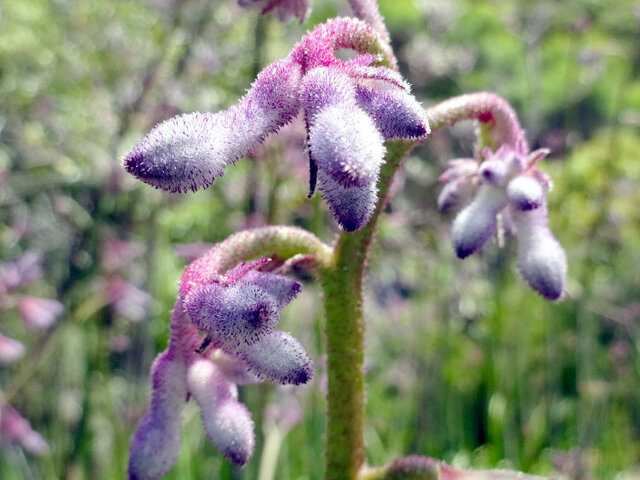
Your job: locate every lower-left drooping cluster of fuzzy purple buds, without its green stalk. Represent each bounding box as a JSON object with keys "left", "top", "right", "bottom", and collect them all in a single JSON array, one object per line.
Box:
[{"left": 129, "top": 251, "right": 313, "bottom": 480}]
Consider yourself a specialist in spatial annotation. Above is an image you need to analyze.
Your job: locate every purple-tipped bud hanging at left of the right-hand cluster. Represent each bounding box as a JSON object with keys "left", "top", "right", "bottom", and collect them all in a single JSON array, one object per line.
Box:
[{"left": 451, "top": 184, "right": 507, "bottom": 258}]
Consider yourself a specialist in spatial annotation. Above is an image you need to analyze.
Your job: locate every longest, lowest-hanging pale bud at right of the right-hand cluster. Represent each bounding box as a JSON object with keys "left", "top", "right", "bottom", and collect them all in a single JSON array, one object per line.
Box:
[{"left": 513, "top": 203, "right": 567, "bottom": 300}]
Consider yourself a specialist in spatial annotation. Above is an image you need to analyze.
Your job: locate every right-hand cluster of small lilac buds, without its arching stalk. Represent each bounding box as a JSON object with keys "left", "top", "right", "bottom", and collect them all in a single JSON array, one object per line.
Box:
[{"left": 438, "top": 142, "right": 567, "bottom": 300}]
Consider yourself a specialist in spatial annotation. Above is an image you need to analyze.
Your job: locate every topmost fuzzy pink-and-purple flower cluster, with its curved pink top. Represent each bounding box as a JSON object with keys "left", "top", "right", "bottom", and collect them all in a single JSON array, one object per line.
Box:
[{"left": 124, "top": 18, "right": 429, "bottom": 231}]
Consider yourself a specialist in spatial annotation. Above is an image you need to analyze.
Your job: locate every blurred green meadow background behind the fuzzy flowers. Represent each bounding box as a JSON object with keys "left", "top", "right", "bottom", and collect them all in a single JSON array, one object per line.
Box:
[{"left": 0, "top": 0, "right": 640, "bottom": 480}]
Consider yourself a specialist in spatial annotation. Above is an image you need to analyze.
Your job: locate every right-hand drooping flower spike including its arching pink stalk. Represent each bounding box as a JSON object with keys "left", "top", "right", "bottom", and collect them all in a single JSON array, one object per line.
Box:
[{"left": 429, "top": 101, "right": 567, "bottom": 300}]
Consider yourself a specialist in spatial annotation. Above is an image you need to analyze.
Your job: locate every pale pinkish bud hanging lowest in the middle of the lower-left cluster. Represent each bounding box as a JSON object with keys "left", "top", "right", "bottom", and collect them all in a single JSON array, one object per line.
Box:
[{"left": 187, "top": 358, "right": 255, "bottom": 465}]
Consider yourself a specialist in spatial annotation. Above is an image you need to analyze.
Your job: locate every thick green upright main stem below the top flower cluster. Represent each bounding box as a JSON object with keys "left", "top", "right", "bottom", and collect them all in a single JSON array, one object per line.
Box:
[{"left": 320, "top": 141, "right": 415, "bottom": 480}]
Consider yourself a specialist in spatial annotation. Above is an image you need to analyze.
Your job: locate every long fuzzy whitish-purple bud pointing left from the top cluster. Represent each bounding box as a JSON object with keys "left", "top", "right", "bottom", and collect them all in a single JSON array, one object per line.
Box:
[{"left": 124, "top": 60, "right": 300, "bottom": 192}]
